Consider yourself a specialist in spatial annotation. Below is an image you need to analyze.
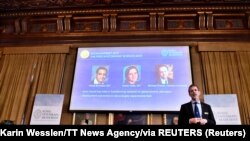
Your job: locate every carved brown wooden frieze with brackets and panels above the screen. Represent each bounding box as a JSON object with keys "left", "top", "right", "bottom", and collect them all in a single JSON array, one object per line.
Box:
[{"left": 0, "top": 4, "right": 250, "bottom": 43}]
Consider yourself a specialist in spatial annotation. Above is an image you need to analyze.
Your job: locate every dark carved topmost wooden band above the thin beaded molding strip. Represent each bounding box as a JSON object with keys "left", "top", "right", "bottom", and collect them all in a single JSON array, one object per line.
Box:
[{"left": 0, "top": 0, "right": 250, "bottom": 11}]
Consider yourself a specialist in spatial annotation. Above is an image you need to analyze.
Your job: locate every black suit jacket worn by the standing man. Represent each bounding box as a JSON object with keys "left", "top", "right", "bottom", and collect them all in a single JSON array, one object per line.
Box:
[{"left": 178, "top": 102, "right": 216, "bottom": 125}]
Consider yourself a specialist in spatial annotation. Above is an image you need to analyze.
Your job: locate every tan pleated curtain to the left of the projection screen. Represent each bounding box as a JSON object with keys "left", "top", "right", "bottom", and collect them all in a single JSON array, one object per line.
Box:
[{"left": 0, "top": 53, "right": 66, "bottom": 124}]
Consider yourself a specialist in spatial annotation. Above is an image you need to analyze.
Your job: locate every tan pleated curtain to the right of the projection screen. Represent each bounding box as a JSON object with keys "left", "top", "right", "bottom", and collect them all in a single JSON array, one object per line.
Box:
[{"left": 201, "top": 51, "right": 250, "bottom": 124}]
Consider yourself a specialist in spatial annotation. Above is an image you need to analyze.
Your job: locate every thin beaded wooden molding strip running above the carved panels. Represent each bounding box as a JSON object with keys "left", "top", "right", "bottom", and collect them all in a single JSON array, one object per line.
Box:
[{"left": 0, "top": 5, "right": 250, "bottom": 17}]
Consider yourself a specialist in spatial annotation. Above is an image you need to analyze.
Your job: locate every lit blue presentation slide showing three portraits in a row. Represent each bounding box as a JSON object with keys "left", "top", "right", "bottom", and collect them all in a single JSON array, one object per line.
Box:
[{"left": 70, "top": 46, "right": 192, "bottom": 111}]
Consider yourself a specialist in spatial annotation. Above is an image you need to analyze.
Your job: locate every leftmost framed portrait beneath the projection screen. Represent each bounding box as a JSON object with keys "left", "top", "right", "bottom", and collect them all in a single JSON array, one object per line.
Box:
[{"left": 72, "top": 112, "right": 97, "bottom": 125}]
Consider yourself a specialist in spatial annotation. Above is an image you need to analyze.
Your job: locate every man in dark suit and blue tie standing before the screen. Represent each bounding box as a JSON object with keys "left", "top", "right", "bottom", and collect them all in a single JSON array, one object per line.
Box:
[{"left": 178, "top": 84, "right": 216, "bottom": 125}]
